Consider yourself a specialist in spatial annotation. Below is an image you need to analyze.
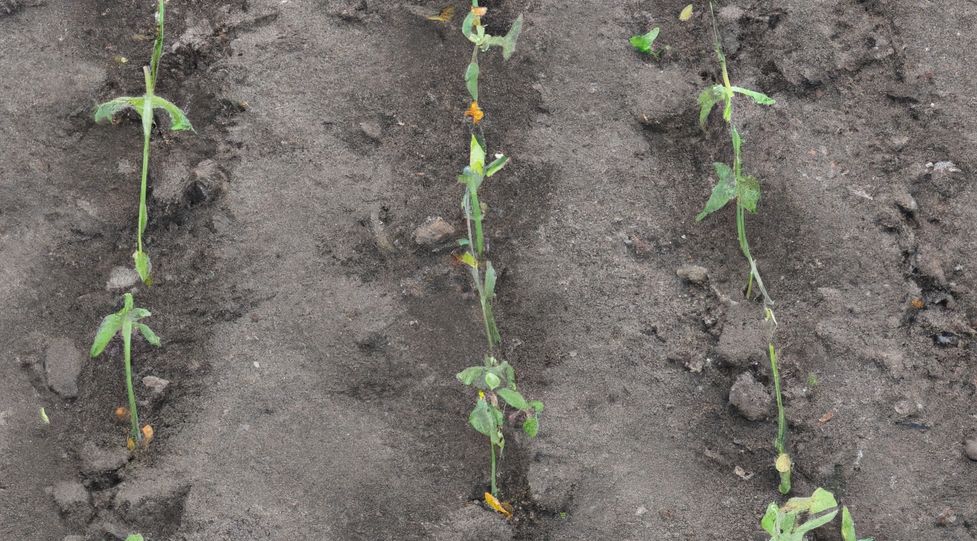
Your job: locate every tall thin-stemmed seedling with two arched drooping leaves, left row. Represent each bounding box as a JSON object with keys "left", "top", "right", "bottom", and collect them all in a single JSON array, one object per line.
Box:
[{"left": 95, "top": 0, "right": 193, "bottom": 285}]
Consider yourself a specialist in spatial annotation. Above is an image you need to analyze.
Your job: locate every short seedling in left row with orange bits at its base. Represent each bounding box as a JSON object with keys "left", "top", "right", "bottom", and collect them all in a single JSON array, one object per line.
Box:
[{"left": 90, "top": 293, "right": 159, "bottom": 450}]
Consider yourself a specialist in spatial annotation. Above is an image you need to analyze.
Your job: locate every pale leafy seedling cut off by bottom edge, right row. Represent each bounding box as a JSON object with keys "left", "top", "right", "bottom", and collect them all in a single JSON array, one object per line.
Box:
[{"left": 760, "top": 488, "right": 873, "bottom": 541}]
